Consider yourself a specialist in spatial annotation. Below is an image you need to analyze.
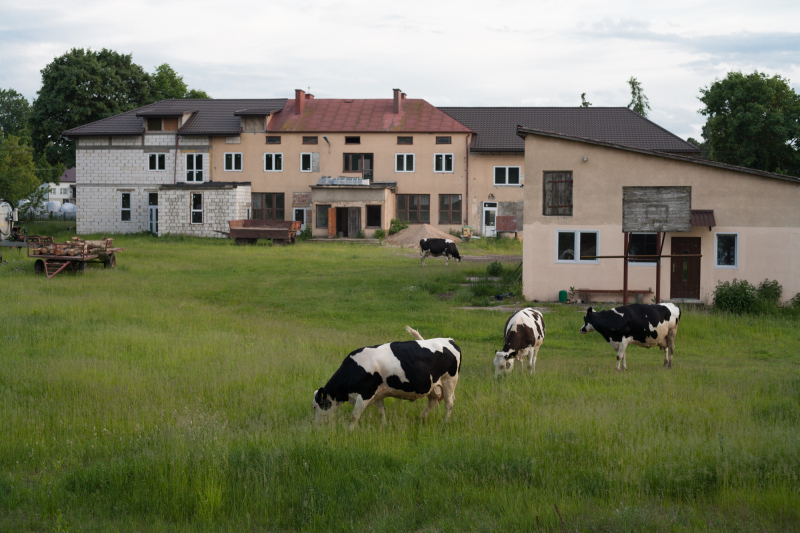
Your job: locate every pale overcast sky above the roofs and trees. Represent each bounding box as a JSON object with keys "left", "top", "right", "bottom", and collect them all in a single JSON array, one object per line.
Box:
[{"left": 0, "top": 0, "right": 800, "bottom": 138}]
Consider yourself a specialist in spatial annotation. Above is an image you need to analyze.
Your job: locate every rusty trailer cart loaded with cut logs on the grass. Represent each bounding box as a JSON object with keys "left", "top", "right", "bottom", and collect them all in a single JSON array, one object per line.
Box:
[{"left": 27, "top": 235, "right": 122, "bottom": 279}]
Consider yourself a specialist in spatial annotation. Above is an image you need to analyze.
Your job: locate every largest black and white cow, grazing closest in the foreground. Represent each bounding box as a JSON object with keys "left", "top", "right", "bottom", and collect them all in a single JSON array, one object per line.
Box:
[{"left": 313, "top": 339, "right": 461, "bottom": 429}]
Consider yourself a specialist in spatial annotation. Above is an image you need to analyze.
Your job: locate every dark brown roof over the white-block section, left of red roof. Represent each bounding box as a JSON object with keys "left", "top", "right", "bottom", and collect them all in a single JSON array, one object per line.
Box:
[{"left": 63, "top": 98, "right": 286, "bottom": 137}]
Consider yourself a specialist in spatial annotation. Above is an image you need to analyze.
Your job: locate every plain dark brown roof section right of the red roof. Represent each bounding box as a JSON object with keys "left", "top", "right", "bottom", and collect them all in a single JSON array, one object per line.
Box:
[{"left": 439, "top": 107, "right": 700, "bottom": 154}]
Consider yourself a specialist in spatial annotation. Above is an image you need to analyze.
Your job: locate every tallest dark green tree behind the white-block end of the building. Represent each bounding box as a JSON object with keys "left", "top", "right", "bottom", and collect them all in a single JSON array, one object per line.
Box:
[{"left": 31, "top": 48, "right": 150, "bottom": 167}]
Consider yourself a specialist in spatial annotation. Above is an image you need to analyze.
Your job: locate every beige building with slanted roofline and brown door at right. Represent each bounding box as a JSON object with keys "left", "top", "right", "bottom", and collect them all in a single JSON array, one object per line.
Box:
[{"left": 519, "top": 128, "right": 800, "bottom": 302}]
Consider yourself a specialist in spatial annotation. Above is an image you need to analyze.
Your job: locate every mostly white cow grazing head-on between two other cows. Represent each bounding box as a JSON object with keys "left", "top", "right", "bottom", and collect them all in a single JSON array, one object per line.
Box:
[{"left": 494, "top": 307, "right": 544, "bottom": 376}]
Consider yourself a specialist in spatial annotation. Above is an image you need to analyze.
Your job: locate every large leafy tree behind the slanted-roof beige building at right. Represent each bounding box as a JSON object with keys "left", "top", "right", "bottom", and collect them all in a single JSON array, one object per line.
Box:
[{"left": 698, "top": 71, "right": 800, "bottom": 177}]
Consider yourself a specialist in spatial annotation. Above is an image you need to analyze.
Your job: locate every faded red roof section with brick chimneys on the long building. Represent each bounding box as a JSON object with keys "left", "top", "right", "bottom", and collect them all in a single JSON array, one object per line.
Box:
[{"left": 269, "top": 98, "right": 472, "bottom": 133}]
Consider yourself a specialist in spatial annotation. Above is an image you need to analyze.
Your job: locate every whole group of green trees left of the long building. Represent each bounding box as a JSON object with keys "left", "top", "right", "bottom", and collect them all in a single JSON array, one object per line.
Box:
[{"left": 0, "top": 48, "right": 210, "bottom": 204}]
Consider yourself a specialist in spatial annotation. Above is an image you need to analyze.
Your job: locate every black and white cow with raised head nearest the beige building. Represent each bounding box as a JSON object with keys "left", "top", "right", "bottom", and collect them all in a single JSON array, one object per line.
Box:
[{"left": 581, "top": 303, "right": 681, "bottom": 372}]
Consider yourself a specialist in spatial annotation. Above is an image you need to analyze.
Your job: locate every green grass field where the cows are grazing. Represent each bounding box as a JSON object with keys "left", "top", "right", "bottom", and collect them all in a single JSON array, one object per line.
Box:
[{"left": 0, "top": 225, "right": 800, "bottom": 532}]
